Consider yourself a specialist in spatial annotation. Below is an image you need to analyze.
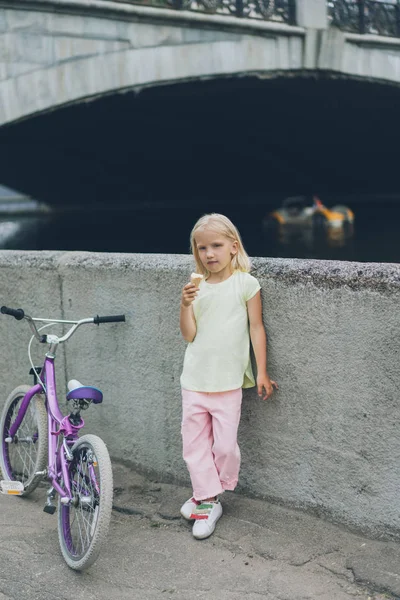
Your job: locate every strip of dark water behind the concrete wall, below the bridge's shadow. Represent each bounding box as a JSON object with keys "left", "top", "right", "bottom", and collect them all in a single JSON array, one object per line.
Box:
[{"left": 0, "top": 200, "right": 400, "bottom": 263}]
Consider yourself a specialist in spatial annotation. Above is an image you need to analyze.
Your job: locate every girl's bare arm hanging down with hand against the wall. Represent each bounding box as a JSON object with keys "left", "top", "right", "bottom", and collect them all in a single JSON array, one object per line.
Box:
[{"left": 247, "top": 292, "right": 278, "bottom": 400}]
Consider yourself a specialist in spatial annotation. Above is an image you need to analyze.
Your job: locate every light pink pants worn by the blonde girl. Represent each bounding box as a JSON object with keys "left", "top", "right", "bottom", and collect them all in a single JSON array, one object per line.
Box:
[{"left": 182, "top": 388, "right": 242, "bottom": 500}]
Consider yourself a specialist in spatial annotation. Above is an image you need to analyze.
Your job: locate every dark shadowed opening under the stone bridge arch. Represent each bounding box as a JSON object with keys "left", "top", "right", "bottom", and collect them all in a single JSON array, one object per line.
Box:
[{"left": 0, "top": 72, "right": 400, "bottom": 205}]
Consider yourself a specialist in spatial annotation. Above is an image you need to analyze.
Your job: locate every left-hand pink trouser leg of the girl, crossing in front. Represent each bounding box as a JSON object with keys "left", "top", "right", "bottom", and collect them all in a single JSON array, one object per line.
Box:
[{"left": 182, "top": 390, "right": 223, "bottom": 500}]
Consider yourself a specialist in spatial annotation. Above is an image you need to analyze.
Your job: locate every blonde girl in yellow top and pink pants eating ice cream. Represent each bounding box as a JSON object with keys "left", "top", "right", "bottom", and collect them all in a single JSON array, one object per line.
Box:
[{"left": 180, "top": 214, "right": 278, "bottom": 539}]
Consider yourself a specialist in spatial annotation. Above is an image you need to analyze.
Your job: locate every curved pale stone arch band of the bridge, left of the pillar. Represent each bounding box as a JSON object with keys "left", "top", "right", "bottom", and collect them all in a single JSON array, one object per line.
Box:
[{"left": 0, "top": 36, "right": 301, "bottom": 126}]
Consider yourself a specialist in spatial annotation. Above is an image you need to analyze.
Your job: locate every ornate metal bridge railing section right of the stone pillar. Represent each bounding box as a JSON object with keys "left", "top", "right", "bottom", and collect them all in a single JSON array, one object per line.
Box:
[{"left": 328, "top": 0, "right": 400, "bottom": 37}]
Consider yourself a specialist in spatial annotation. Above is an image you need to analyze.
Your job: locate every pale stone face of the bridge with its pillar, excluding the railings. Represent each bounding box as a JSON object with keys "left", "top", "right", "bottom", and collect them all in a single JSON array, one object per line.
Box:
[{"left": 0, "top": 0, "right": 400, "bottom": 125}]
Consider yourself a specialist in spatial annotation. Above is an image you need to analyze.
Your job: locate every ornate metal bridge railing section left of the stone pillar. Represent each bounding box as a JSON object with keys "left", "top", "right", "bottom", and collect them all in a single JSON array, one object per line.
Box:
[{"left": 111, "top": 0, "right": 296, "bottom": 25}]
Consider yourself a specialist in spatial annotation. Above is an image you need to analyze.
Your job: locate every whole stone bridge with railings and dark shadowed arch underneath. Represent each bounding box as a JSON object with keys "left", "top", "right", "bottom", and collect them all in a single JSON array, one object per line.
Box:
[{"left": 0, "top": 0, "right": 400, "bottom": 203}]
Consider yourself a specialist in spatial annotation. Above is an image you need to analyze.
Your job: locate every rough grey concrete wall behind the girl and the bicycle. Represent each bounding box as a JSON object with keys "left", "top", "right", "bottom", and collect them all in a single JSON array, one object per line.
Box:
[{"left": 0, "top": 251, "right": 400, "bottom": 536}]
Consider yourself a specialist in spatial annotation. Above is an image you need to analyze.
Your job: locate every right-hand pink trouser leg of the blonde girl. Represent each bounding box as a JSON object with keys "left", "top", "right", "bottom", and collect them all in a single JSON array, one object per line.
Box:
[{"left": 211, "top": 388, "right": 242, "bottom": 490}]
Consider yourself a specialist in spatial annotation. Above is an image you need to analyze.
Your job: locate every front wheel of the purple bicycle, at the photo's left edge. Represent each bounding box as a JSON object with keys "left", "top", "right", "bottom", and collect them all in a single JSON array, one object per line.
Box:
[{"left": 0, "top": 385, "right": 48, "bottom": 496}]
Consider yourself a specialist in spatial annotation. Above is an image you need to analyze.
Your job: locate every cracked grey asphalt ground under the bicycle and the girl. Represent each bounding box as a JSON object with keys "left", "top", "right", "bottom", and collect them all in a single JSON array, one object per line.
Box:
[{"left": 0, "top": 466, "right": 400, "bottom": 600}]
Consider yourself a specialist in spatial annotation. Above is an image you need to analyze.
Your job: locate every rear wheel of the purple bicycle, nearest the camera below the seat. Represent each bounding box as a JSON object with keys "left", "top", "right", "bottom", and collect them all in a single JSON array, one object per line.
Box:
[{"left": 58, "top": 434, "right": 113, "bottom": 571}]
